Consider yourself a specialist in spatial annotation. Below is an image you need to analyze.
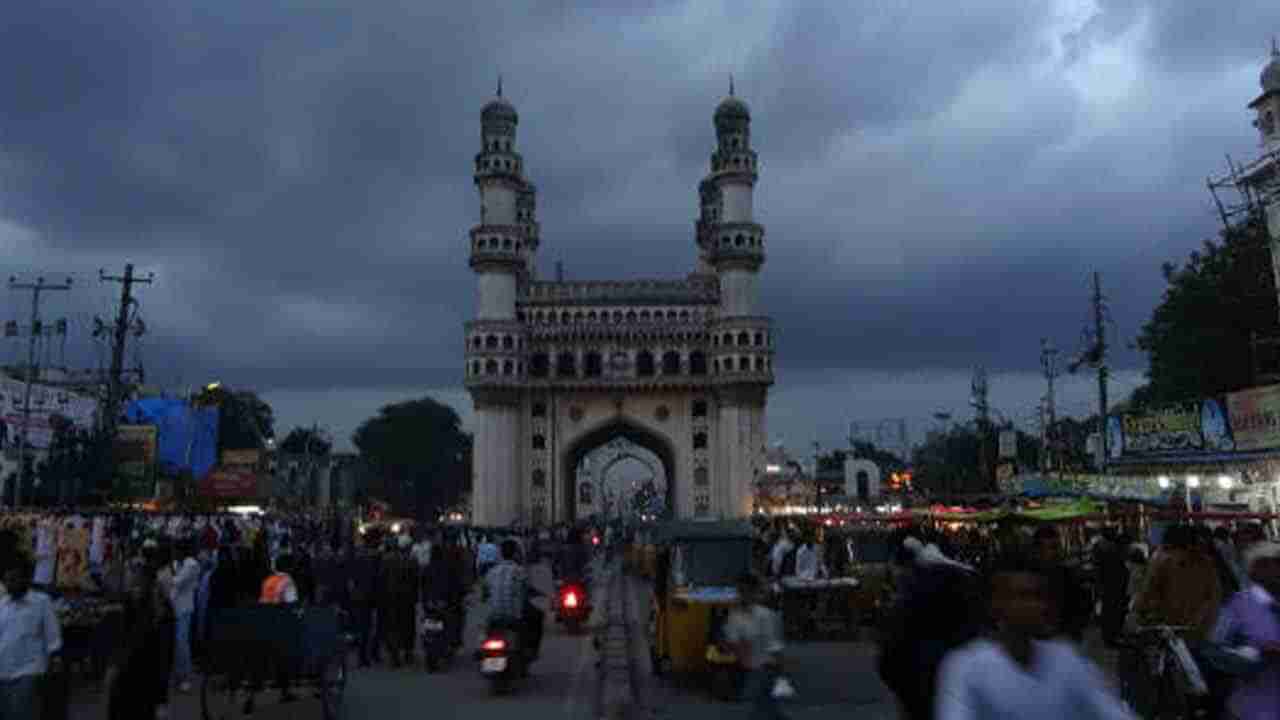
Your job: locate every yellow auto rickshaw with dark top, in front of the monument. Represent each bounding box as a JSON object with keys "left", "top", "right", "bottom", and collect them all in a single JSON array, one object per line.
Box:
[{"left": 649, "top": 521, "right": 753, "bottom": 694}]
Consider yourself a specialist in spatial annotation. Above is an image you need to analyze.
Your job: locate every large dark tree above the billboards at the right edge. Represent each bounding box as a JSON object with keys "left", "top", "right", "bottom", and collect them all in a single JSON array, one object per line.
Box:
[{"left": 1133, "top": 210, "right": 1280, "bottom": 407}]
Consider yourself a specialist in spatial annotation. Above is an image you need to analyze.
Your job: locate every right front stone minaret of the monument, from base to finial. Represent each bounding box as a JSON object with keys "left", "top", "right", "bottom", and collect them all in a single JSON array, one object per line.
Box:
[{"left": 698, "top": 81, "right": 773, "bottom": 518}]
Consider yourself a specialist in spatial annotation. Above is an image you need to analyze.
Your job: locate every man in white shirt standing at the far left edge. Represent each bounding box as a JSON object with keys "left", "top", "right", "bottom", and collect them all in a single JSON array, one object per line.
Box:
[{"left": 0, "top": 560, "right": 63, "bottom": 720}]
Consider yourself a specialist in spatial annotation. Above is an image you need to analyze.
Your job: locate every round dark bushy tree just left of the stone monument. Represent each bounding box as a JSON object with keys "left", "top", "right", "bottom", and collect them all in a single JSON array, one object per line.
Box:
[{"left": 352, "top": 397, "right": 471, "bottom": 518}]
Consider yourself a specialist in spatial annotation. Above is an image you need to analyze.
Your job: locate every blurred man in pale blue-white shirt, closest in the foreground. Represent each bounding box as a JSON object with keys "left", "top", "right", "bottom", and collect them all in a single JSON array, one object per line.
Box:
[{"left": 936, "top": 553, "right": 1133, "bottom": 720}]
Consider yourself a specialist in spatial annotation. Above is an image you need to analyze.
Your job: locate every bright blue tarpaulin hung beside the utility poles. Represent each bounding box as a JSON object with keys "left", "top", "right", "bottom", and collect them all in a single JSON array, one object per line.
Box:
[{"left": 124, "top": 397, "right": 218, "bottom": 480}]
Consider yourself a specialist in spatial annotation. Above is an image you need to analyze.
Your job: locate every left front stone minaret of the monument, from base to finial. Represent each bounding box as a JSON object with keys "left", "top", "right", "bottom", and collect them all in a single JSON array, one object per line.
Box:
[{"left": 466, "top": 79, "right": 538, "bottom": 525}]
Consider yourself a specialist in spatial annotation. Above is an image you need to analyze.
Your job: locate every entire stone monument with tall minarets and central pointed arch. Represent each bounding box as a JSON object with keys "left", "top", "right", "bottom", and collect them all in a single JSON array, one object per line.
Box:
[{"left": 466, "top": 83, "right": 774, "bottom": 527}]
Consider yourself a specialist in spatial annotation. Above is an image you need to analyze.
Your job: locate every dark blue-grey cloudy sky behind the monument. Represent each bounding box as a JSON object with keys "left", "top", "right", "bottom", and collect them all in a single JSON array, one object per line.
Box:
[{"left": 0, "top": 0, "right": 1280, "bottom": 447}]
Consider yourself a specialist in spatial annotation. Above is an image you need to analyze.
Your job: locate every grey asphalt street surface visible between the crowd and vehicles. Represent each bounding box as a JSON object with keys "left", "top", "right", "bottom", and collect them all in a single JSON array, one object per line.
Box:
[{"left": 70, "top": 564, "right": 895, "bottom": 720}]
